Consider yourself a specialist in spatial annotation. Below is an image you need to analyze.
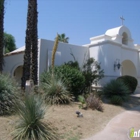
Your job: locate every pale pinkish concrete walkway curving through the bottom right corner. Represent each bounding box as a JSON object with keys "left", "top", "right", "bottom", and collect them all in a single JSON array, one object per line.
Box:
[{"left": 85, "top": 106, "right": 140, "bottom": 140}]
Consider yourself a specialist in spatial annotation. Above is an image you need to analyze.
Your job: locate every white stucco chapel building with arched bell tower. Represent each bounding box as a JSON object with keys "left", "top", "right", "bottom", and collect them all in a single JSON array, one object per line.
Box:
[{"left": 4, "top": 26, "right": 140, "bottom": 91}]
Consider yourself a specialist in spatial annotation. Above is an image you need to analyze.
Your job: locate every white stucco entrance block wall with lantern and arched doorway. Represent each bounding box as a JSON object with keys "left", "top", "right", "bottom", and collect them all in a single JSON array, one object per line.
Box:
[{"left": 89, "top": 41, "right": 140, "bottom": 86}]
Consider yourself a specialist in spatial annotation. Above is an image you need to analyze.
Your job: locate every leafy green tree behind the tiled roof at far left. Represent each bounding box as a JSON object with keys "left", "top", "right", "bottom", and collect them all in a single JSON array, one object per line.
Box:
[{"left": 4, "top": 33, "right": 16, "bottom": 53}]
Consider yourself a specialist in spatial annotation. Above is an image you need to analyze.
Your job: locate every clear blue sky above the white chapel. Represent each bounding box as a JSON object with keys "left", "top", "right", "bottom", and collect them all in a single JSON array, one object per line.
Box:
[{"left": 4, "top": 0, "right": 140, "bottom": 48}]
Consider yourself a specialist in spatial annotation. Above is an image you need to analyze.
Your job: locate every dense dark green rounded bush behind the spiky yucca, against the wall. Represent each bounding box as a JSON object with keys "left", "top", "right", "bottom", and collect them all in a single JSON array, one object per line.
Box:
[{"left": 55, "top": 65, "right": 85, "bottom": 98}]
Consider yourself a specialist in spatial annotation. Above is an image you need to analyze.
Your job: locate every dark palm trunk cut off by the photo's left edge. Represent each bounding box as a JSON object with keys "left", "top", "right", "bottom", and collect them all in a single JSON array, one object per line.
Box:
[{"left": 0, "top": 0, "right": 5, "bottom": 73}]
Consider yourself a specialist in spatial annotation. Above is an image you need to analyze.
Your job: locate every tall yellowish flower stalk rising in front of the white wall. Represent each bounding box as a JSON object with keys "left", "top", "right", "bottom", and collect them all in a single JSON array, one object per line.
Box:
[{"left": 52, "top": 34, "right": 59, "bottom": 69}]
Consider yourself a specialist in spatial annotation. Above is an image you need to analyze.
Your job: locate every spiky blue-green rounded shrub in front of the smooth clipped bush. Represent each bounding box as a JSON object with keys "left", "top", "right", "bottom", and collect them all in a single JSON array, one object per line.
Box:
[{"left": 103, "top": 80, "right": 130, "bottom": 101}]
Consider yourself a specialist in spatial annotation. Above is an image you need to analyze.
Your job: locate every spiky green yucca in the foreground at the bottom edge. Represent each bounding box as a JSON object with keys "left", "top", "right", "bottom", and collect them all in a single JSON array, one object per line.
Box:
[{"left": 12, "top": 94, "right": 58, "bottom": 140}]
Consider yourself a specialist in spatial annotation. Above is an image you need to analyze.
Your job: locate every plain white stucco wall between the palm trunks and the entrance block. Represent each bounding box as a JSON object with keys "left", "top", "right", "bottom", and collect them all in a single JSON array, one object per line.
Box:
[{"left": 39, "top": 39, "right": 88, "bottom": 79}]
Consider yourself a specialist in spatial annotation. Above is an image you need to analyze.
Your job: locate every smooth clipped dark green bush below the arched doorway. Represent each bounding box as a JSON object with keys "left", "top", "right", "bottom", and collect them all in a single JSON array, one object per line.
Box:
[{"left": 117, "top": 75, "right": 138, "bottom": 93}]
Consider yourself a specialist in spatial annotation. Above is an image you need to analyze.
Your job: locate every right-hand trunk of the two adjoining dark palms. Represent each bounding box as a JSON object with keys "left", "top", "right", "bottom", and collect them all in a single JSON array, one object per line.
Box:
[{"left": 31, "top": 0, "right": 38, "bottom": 85}]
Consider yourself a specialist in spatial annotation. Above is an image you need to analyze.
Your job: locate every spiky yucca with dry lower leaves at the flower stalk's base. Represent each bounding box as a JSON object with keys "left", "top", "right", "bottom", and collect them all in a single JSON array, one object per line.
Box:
[{"left": 41, "top": 71, "right": 73, "bottom": 104}]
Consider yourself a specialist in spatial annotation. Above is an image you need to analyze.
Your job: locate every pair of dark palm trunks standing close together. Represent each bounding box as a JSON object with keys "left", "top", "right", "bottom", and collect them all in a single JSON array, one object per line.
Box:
[{"left": 21, "top": 0, "right": 38, "bottom": 89}]
